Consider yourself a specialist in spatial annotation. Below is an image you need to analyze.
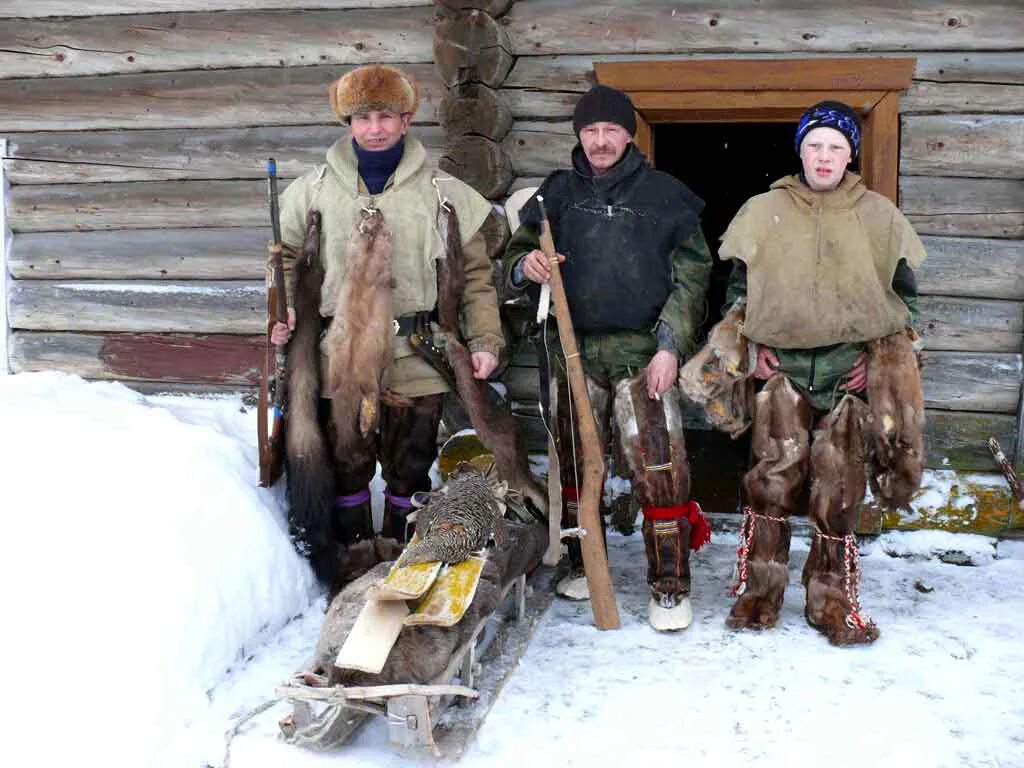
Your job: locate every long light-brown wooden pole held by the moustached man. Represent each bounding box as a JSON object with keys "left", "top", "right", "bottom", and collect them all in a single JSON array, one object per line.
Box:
[{"left": 537, "top": 197, "right": 620, "bottom": 630}]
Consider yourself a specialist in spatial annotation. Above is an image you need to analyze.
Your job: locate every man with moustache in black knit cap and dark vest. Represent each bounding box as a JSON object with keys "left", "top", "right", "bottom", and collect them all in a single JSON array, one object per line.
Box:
[{"left": 506, "top": 85, "right": 712, "bottom": 630}]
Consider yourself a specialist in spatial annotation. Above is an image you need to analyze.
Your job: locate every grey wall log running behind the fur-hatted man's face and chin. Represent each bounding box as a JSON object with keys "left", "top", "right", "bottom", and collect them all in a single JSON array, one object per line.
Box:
[{"left": 5, "top": 124, "right": 446, "bottom": 184}]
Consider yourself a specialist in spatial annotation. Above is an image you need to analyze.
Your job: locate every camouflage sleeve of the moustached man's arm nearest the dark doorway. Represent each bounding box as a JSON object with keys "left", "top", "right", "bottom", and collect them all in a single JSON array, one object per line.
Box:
[{"left": 658, "top": 228, "right": 712, "bottom": 356}]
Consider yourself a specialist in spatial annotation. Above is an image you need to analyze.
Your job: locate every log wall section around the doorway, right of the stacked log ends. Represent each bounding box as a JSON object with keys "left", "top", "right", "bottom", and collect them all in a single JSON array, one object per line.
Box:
[{"left": 450, "top": 0, "right": 1024, "bottom": 469}]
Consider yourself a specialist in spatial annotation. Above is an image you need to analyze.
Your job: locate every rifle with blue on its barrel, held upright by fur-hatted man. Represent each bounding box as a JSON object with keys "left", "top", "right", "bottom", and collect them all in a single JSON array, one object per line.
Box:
[{"left": 256, "top": 158, "right": 288, "bottom": 487}]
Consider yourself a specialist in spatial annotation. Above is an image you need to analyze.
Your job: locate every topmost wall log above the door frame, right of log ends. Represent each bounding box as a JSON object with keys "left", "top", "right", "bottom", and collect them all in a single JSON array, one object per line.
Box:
[{"left": 507, "top": 0, "right": 1024, "bottom": 55}]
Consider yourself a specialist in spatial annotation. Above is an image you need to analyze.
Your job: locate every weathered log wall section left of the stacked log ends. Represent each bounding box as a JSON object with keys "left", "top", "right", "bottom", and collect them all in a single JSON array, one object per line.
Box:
[{"left": 0, "top": 0, "right": 444, "bottom": 389}]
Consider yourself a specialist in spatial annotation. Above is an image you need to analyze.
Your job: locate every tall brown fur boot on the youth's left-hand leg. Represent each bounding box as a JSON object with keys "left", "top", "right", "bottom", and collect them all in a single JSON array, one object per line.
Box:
[{"left": 726, "top": 374, "right": 811, "bottom": 629}]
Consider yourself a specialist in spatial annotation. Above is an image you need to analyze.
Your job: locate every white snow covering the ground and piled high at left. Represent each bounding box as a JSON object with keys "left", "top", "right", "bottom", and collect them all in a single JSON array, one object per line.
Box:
[{"left": 0, "top": 374, "right": 1024, "bottom": 768}]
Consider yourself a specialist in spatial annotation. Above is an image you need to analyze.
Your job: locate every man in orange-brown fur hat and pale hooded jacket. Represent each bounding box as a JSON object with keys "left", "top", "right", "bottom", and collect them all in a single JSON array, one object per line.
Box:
[{"left": 271, "top": 65, "right": 504, "bottom": 586}]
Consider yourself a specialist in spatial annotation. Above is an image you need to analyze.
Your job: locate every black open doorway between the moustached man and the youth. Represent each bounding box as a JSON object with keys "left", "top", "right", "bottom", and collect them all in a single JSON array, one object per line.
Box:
[{"left": 653, "top": 123, "right": 800, "bottom": 512}]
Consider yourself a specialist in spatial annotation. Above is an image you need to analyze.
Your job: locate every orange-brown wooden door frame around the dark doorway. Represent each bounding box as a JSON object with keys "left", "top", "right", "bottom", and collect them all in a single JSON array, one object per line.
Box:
[{"left": 594, "top": 58, "right": 918, "bottom": 203}]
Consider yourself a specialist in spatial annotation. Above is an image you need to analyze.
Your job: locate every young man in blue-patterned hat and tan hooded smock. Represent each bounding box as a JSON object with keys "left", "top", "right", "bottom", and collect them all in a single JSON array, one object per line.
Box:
[{"left": 712, "top": 101, "right": 925, "bottom": 645}]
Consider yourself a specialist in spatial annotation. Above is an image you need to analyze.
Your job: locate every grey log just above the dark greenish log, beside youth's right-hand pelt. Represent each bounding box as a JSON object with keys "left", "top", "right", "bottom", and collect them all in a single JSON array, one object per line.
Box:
[{"left": 922, "top": 352, "right": 1021, "bottom": 415}]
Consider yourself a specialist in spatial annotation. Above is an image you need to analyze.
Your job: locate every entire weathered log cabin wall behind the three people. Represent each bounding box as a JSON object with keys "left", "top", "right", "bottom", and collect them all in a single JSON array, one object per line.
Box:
[{"left": 0, "top": 0, "right": 1024, "bottom": 469}]
